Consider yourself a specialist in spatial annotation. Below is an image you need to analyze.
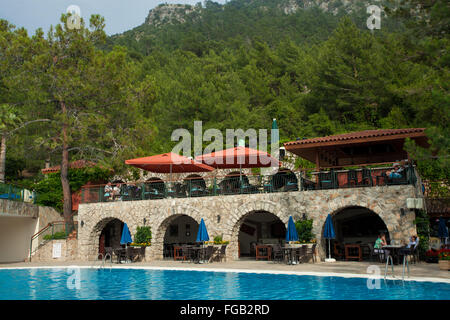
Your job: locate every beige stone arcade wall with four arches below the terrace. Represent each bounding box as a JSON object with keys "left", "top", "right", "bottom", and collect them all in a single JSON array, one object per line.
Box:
[{"left": 78, "top": 186, "right": 416, "bottom": 260}]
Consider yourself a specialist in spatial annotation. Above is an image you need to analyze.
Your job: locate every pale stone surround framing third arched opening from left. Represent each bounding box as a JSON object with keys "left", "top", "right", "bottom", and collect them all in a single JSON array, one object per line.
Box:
[{"left": 223, "top": 201, "right": 289, "bottom": 260}]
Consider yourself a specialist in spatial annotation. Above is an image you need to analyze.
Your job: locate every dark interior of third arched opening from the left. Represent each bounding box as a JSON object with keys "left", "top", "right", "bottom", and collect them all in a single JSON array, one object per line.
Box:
[{"left": 238, "top": 211, "right": 286, "bottom": 259}]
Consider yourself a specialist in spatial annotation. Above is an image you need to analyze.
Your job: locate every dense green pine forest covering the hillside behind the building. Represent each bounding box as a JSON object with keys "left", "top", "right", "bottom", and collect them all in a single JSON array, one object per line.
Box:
[{"left": 0, "top": 0, "right": 450, "bottom": 192}]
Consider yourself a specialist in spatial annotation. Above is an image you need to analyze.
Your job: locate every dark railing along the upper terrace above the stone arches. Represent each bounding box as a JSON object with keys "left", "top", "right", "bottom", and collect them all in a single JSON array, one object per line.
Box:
[{"left": 81, "top": 167, "right": 417, "bottom": 203}]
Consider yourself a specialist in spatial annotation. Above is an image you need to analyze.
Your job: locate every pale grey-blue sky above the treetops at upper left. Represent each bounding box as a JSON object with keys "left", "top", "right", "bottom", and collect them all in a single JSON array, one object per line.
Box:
[{"left": 0, "top": 0, "right": 225, "bottom": 35}]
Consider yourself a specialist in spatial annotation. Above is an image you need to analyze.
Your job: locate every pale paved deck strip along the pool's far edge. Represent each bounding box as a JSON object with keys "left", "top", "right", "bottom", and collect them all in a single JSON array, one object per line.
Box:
[{"left": 0, "top": 259, "right": 450, "bottom": 283}]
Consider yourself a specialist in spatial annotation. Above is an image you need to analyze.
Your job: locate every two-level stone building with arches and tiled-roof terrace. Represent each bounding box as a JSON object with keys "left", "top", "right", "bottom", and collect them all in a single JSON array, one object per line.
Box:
[{"left": 78, "top": 129, "right": 424, "bottom": 260}]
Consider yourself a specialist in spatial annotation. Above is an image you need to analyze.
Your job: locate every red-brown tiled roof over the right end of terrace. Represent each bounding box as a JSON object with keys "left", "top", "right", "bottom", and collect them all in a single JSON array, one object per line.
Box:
[{"left": 284, "top": 128, "right": 425, "bottom": 146}]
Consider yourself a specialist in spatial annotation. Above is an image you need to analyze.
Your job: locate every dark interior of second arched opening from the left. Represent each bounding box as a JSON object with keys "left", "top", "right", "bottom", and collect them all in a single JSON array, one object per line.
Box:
[{"left": 163, "top": 214, "right": 199, "bottom": 259}]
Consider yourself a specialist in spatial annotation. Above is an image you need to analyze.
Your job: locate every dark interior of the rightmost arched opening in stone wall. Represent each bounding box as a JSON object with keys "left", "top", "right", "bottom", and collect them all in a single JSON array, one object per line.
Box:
[{"left": 322, "top": 206, "right": 390, "bottom": 260}]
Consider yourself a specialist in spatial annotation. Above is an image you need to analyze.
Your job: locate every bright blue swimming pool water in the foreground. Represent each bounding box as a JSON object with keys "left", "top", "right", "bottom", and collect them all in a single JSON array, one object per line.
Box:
[{"left": 0, "top": 268, "right": 450, "bottom": 300}]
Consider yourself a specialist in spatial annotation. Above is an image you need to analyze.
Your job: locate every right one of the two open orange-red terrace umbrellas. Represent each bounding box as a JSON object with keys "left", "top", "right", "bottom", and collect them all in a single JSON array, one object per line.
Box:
[{"left": 195, "top": 146, "right": 280, "bottom": 169}]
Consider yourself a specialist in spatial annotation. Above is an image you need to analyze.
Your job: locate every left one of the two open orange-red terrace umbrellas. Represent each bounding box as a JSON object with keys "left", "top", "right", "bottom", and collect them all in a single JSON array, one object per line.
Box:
[{"left": 125, "top": 152, "right": 214, "bottom": 174}]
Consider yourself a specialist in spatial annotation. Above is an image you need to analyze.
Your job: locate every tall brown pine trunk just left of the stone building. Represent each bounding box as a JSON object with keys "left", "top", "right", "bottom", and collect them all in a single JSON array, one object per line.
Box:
[{"left": 61, "top": 102, "right": 73, "bottom": 233}]
